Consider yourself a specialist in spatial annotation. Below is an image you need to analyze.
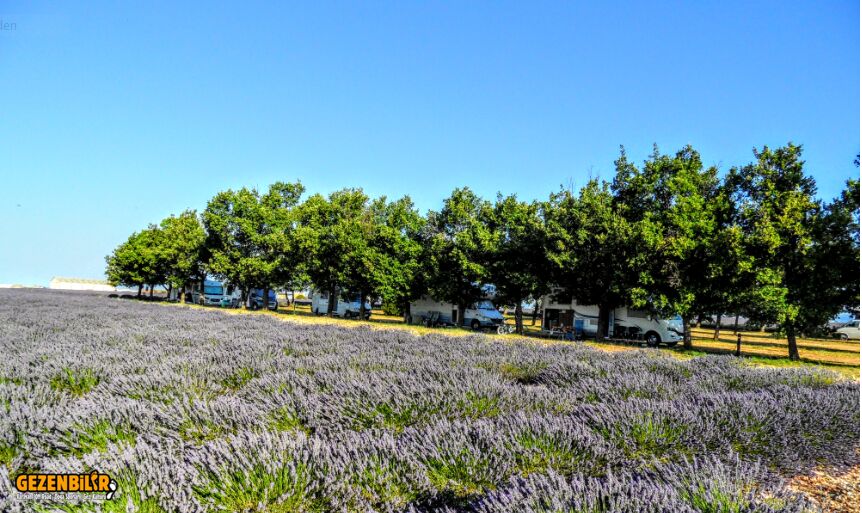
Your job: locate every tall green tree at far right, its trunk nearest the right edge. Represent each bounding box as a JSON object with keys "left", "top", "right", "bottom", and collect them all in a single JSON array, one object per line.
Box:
[{"left": 731, "top": 143, "right": 859, "bottom": 360}]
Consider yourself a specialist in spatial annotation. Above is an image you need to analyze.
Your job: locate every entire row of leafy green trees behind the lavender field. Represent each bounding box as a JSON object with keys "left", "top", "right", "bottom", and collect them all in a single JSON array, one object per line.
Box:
[{"left": 107, "top": 144, "right": 859, "bottom": 359}]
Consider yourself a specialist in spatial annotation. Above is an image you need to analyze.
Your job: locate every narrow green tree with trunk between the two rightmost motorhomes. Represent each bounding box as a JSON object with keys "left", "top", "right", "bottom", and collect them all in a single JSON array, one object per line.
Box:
[{"left": 481, "top": 194, "right": 549, "bottom": 334}]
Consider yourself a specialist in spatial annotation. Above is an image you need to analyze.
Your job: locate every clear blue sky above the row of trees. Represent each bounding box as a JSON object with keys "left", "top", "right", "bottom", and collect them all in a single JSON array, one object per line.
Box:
[{"left": 0, "top": 1, "right": 859, "bottom": 284}]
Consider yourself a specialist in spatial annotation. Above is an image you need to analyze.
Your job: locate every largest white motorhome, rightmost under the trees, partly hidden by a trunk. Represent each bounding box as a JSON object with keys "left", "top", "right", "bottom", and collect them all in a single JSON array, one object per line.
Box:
[{"left": 542, "top": 295, "right": 682, "bottom": 347}]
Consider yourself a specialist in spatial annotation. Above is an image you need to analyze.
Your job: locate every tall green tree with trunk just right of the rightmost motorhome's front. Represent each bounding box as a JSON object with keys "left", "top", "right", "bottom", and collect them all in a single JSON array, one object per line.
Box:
[{"left": 614, "top": 146, "right": 729, "bottom": 349}]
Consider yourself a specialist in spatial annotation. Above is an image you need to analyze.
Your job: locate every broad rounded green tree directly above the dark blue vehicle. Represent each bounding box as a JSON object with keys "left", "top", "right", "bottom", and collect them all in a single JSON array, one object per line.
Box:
[{"left": 203, "top": 182, "right": 305, "bottom": 302}]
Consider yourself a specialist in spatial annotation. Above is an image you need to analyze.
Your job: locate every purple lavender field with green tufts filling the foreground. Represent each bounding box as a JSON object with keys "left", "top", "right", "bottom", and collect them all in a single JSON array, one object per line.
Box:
[{"left": 0, "top": 290, "right": 859, "bottom": 513}]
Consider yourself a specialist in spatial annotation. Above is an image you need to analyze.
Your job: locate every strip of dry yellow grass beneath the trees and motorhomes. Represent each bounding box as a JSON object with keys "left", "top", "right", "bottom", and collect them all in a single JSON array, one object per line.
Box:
[{"left": 164, "top": 305, "right": 860, "bottom": 380}]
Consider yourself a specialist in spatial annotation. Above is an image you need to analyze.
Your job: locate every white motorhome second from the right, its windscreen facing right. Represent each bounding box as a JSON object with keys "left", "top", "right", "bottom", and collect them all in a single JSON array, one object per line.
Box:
[{"left": 407, "top": 285, "right": 503, "bottom": 330}]
